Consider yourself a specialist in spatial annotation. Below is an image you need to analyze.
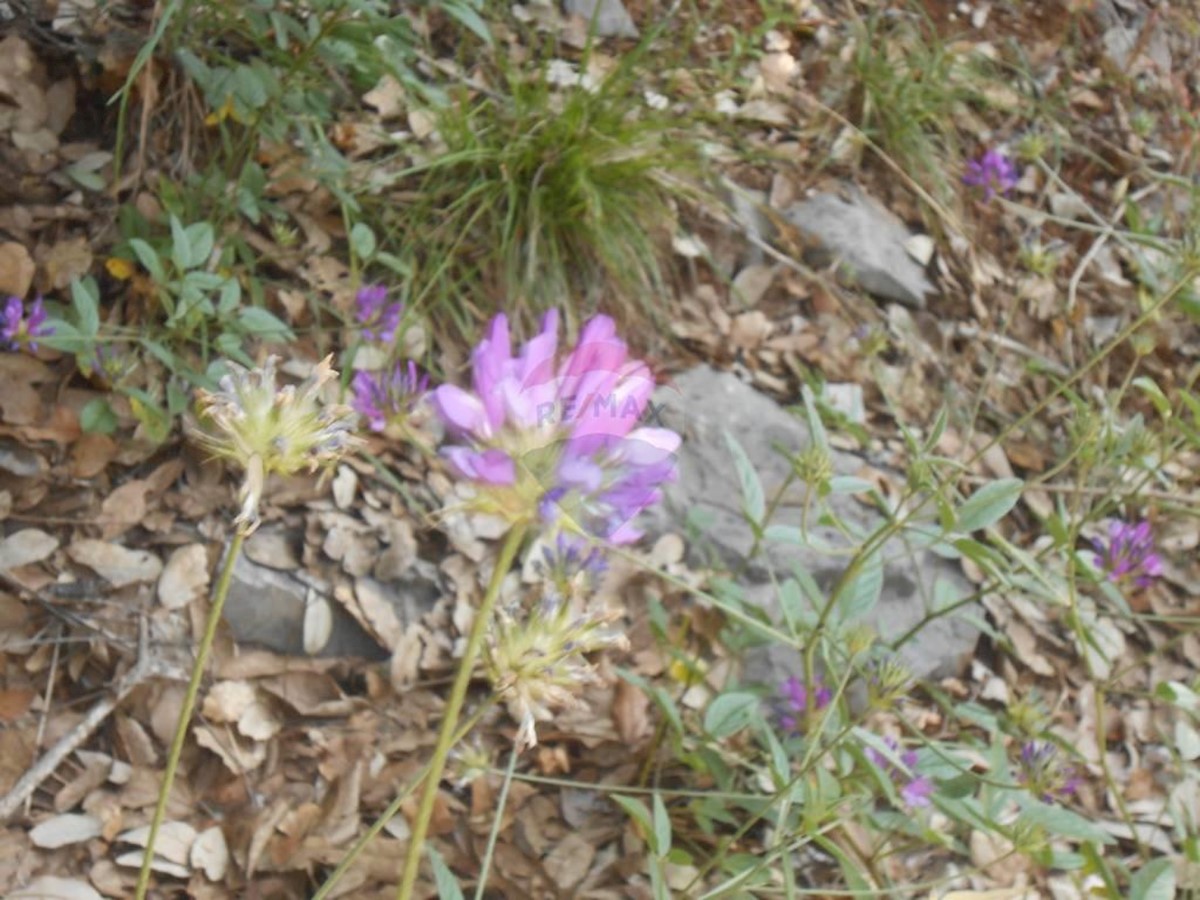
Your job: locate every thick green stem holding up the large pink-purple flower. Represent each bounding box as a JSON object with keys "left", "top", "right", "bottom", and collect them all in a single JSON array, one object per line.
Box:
[{"left": 396, "top": 526, "right": 526, "bottom": 900}]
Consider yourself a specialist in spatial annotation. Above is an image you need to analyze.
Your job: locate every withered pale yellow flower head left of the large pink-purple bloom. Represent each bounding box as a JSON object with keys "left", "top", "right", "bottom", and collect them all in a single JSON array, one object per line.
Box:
[{"left": 190, "top": 356, "right": 358, "bottom": 533}]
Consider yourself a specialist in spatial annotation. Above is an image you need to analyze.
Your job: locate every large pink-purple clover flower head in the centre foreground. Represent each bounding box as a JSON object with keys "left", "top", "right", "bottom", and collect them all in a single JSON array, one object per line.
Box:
[{"left": 430, "top": 310, "right": 679, "bottom": 544}]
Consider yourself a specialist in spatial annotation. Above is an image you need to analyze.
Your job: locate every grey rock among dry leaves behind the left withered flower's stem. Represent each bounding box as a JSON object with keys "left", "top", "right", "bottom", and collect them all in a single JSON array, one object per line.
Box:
[{"left": 224, "top": 554, "right": 388, "bottom": 660}]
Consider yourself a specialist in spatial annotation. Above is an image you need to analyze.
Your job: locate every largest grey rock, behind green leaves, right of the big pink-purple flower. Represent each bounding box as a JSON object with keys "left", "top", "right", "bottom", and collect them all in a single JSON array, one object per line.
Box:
[{"left": 644, "top": 366, "right": 979, "bottom": 680}]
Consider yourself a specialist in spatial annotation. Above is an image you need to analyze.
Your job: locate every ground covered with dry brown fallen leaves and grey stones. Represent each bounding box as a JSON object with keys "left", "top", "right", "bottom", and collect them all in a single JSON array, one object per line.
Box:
[{"left": 0, "top": 1, "right": 1200, "bottom": 899}]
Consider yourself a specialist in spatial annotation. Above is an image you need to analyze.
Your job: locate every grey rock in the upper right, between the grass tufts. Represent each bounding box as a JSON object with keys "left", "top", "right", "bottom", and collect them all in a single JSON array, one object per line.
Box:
[{"left": 785, "top": 186, "right": 934, "bottom": 310}]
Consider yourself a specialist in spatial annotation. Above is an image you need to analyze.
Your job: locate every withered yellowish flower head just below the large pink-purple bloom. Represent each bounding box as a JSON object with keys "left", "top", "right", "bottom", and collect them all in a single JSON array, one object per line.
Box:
[{"left": 484, "top": 595, "right": 629, "bottom": 750}]
